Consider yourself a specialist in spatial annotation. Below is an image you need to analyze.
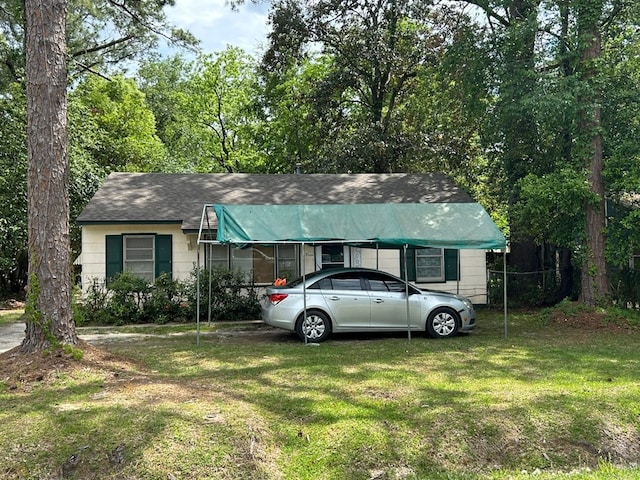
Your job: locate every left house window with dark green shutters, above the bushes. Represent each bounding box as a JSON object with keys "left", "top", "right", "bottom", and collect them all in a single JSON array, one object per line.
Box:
[{"left": 105, "top": 234, "right": 173, "bottom": 282}]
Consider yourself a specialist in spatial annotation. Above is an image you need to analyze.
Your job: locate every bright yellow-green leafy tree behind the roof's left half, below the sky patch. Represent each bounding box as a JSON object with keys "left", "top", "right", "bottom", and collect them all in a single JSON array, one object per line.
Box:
[{"left": 140, "top": 47, "right": 267, "bottom": 172}]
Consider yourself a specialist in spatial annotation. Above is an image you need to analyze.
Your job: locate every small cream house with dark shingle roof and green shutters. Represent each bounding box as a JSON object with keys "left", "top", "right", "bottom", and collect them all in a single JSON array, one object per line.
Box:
[{"left": 77, "top": 173, "right": 500, "bottom": 304}]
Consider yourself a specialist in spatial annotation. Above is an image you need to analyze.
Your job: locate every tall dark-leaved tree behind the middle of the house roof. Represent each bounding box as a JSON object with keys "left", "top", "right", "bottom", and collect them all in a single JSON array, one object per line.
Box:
[{"left": 262, "top": 0, "right": 456, "bottom": 172}]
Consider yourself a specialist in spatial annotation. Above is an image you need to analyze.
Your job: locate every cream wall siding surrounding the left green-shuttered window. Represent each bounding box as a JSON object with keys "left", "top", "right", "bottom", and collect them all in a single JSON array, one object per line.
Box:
[{"left": 81, "top": 224, "right": 196, "bottom": 289}]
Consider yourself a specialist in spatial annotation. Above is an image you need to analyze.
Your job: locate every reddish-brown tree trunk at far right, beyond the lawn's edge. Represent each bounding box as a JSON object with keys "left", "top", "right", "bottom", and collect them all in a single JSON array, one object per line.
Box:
[{"left": 578, "top": 0, "right": 609, "bottom": 306}]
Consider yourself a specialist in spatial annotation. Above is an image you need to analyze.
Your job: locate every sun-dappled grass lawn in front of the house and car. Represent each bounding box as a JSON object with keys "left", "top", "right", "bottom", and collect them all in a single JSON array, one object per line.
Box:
[{"left": 0, "top": 311, "right": 640, "bottom": 480}]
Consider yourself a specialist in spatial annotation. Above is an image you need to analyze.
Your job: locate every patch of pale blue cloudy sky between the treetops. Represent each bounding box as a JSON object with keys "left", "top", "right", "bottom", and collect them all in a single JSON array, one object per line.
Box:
[{"left": 165, "top": 0, "right": 269, "bottom": 56}]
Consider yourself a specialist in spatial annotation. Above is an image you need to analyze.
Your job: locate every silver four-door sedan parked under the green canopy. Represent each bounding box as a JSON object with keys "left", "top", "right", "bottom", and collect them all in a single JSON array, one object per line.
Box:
[{"left": 262, "top": 268, "right": 476, "bottom": 342}]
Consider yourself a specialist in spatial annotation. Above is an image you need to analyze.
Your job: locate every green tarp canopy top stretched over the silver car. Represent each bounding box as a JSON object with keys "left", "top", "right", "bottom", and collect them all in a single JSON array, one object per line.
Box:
[{"left": 213, "top": 203, "right": 506, "bottom": 249}]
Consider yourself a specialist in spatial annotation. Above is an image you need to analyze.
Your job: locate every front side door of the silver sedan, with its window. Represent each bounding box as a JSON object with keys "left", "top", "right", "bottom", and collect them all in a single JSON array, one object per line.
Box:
[{"left": 365, "top": 272, "right": 422, "bottom": 330}]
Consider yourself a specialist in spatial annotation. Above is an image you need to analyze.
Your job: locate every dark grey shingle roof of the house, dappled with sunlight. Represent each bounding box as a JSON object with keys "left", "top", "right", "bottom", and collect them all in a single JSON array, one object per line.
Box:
[{"left": 77, "top": 173, "right": 473, "bottom": 230}]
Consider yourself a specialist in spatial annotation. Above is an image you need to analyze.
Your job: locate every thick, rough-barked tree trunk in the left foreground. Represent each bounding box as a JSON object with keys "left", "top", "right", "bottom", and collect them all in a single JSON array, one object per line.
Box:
[{"left": 22, "top": 0, "right": 78, "bottom": 352}]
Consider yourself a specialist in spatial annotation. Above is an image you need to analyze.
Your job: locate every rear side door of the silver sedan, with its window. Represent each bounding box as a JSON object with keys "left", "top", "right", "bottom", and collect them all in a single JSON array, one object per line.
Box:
[{"left": 319, "top": 272, "right": 371, "bottom": 330}]
